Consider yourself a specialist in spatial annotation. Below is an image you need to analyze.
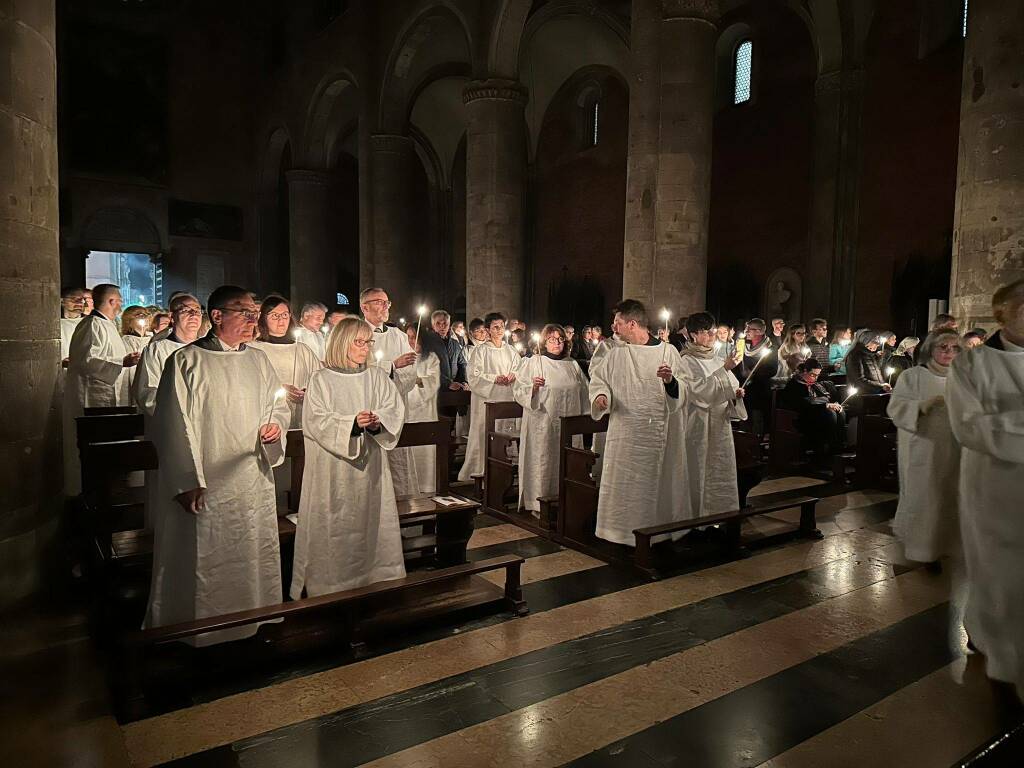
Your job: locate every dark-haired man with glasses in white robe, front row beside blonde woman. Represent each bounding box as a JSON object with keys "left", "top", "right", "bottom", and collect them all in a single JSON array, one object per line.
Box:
[{"left": 144, "top": 286, "right": 291, "bottom": 645}]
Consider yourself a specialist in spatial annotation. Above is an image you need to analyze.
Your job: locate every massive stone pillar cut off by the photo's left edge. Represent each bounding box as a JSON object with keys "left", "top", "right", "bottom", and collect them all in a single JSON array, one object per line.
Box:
[{"left": 0, "top": 0, "right": 63, "bottom": 607}]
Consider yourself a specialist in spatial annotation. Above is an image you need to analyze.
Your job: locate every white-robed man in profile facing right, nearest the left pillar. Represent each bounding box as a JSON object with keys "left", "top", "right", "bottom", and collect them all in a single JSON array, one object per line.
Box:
[{"left": 63, "top": 284, "right": 140, "bottom": 496}]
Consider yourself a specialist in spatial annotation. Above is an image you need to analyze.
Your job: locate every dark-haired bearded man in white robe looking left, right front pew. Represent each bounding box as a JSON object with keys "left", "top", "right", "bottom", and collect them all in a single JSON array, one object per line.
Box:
[{"left": 589, "top": 299, "right": 690, "bottom": 546}]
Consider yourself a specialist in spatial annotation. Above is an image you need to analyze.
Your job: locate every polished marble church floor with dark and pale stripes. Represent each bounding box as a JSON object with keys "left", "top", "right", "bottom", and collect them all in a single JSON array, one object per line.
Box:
[{"left": 0, "top": 477, "right": 1024, "bottom": 768}]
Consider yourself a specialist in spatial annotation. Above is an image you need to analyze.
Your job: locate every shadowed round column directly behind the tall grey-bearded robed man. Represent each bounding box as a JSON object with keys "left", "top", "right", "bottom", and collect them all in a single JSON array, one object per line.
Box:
[{"left": 368, "top": 133, "right": 415, "bottom": 311}]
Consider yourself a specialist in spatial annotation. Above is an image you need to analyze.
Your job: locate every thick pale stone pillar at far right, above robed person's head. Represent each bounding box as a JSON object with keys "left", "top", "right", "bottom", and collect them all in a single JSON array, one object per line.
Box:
[{"left": 950, "top": 0, "right": 1024, "bottom": 328}]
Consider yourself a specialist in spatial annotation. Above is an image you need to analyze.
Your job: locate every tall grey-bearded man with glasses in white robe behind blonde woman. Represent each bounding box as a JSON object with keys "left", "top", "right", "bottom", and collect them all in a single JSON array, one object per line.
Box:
[{"left": 359, "top": 288, "right": 419, "bottom": 496}]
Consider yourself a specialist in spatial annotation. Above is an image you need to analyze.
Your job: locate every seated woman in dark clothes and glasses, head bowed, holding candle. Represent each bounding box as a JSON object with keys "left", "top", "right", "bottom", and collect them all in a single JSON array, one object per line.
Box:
[{"left": 777, "top": 357, "right": 846, "bottom": 460}]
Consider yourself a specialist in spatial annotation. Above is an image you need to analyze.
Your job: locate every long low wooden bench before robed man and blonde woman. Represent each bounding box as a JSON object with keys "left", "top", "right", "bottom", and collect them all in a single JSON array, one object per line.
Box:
[{"left": 116, "top": 555, "right": 528, "bottom": 718}]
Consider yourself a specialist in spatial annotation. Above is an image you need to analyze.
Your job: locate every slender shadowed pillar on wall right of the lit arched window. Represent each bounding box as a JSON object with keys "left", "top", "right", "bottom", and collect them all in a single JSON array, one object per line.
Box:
[{"left": 804, "top": 69, "right": 864, "bottom": 326}]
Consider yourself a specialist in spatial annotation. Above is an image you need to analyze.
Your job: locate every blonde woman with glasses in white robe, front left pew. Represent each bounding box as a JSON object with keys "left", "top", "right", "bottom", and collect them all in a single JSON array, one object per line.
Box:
[{"left": 291, "top": 317, "right": 406, "bottom": 599}]
